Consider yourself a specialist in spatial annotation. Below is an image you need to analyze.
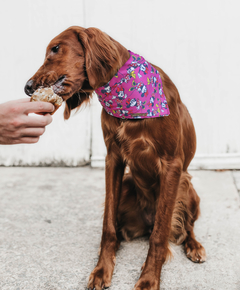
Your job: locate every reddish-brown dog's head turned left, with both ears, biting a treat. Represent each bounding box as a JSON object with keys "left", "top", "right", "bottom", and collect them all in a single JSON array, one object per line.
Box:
[{"left": 25, "top": 26, "right": 121, "bottom": 119}]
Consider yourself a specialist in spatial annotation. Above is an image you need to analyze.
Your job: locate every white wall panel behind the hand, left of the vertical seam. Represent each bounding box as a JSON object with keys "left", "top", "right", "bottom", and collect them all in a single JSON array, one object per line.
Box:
[{"left": 0, "top": 0, "right": 91, "bottom": 166}]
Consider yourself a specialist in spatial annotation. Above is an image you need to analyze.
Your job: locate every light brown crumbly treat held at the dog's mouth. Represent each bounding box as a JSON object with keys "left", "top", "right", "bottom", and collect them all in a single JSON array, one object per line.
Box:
[{"left": 31, "top": 88, "right": 63, "bottom": 115}]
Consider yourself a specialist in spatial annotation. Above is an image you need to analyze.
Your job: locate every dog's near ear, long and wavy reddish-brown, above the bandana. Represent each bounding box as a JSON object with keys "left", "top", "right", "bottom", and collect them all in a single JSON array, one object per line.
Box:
[{"left": 76, "top": 27, "right": 121, "bottom": 89}]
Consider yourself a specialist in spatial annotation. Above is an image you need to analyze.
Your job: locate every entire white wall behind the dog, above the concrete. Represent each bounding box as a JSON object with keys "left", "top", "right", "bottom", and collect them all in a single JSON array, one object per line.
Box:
[{"left": 0, "top": 0, "right": 240, "bottom": 168}]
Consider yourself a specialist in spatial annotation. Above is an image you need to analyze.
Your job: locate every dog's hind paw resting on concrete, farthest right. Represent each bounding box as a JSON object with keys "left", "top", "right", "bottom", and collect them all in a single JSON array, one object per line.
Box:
[{"left": 184, "top": 240, "right": 207, "bottom": 263}]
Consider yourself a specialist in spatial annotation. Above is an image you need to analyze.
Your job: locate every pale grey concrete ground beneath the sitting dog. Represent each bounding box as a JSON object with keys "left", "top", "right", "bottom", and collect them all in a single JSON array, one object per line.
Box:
[{"left": 0, "top": 167, "right": 240, "bottom": 290}]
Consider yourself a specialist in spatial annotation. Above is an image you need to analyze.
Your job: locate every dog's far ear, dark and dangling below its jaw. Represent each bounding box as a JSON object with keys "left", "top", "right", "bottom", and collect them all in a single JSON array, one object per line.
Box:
[{"left": 64, "top": 80, "right": 93, "bottom": 120}]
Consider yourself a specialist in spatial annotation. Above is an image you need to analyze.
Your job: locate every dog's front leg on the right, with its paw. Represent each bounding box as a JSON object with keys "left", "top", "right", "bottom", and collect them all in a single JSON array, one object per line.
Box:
[{"left": 134, "top": 159, "right": 182, "bottom": 290}]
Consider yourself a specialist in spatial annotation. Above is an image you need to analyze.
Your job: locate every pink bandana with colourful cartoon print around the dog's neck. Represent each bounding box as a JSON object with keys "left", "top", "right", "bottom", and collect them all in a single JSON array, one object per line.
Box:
[{"left": 95, "top": 51, "right": 170, "bottom": 119}]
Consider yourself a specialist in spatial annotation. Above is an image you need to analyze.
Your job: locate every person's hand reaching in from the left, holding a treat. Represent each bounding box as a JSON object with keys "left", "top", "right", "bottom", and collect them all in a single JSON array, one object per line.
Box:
[{"left": 0, "top": 98, "right": 54, "bottom": 144}]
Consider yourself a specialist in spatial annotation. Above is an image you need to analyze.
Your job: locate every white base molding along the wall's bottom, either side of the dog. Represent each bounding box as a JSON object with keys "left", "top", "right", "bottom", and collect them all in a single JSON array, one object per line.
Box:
[{"left": 91, "top": 153, "right": 240, "bottom": 170}]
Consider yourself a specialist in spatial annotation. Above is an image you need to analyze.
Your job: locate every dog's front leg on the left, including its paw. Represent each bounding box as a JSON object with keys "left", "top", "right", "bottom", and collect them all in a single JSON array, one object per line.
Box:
[{"left": 88, "top": 155, "right": 124, "bottom": 290}]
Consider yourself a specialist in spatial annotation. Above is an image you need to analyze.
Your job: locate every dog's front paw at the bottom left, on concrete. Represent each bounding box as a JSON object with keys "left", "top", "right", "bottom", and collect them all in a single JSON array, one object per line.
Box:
[{"left": 87, "top": 265, "right": 113, "bottom": 290}]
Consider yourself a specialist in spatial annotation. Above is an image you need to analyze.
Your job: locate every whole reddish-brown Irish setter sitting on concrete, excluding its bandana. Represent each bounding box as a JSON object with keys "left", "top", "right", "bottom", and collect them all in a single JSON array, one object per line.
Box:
[{"left": 25, "top": 26, "right": 206, "bottom": 290}]
